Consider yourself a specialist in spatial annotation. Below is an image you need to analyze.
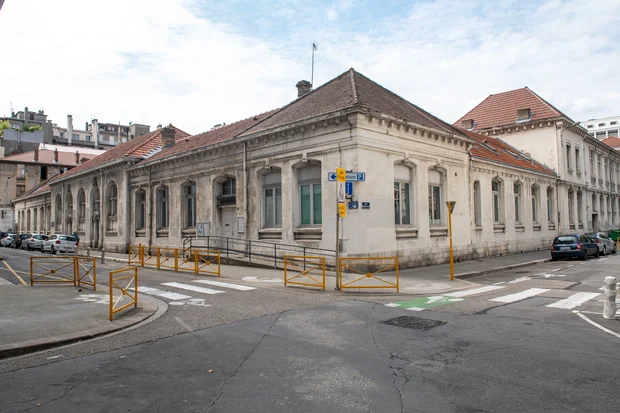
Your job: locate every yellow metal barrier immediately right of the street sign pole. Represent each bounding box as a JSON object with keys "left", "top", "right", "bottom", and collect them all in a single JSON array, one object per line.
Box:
[{"left": 338, "top": 257, "right": 400, "bottom": 292}]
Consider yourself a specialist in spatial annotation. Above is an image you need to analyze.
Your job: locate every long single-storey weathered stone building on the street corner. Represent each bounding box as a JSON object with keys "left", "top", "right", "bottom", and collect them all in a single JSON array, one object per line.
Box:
[{"left": 14, "top": 69, "right": 572, "bottom": 266}]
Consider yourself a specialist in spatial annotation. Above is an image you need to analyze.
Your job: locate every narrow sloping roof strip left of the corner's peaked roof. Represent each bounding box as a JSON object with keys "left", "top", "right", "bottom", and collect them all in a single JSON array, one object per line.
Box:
[{"left": 146, "top": 110, "right": 275, "bottom": 163}]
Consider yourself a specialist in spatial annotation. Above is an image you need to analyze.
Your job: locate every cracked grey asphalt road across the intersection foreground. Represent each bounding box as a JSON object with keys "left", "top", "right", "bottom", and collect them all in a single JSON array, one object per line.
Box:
[{"left": 0, "top": 246, "right": 620, "bottom": 412}]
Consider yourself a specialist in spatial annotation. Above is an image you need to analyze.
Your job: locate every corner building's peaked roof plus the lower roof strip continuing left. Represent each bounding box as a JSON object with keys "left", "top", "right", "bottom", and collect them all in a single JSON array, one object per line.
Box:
[{"left": 145, "top": 69, "right": 462, "bottom": 163}]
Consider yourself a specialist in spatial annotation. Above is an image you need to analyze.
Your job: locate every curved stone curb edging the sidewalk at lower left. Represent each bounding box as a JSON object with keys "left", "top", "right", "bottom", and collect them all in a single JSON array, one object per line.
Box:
[{"left": 0, "top": 286, "right": 168, "bottom": 360}]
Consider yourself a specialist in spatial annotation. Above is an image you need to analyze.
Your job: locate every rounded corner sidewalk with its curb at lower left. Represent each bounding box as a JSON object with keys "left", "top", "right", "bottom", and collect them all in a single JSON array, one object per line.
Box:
[{"left": 0, "top": 285, "right": 167, "bottom": 359}]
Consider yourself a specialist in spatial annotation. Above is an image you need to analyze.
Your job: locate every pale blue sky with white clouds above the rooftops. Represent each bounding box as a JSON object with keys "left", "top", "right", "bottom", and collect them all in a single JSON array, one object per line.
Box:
[{"left": 0, "top": 0, "right": 620, "bottom": 134}]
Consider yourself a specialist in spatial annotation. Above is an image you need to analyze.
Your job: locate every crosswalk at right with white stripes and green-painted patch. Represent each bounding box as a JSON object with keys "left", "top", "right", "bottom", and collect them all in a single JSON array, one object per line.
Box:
[{"left": 385, "top": 283, "right": 601, "bottom": 311}]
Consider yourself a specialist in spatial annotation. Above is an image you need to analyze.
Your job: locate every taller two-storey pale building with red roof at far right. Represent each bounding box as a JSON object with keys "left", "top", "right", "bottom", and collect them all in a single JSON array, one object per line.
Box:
[{"left": 454, "top": 87, "right": 620, "bottom": 240}]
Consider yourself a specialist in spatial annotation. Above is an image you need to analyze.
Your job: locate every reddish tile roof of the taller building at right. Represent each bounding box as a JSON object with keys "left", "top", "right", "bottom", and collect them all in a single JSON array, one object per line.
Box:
[{"left": 453, "top": 87, "right": 572, "bottom": 132}]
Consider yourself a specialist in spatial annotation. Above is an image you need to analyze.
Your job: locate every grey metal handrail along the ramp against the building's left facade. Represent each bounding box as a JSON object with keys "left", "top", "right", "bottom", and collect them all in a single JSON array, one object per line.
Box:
[{"left": 183, "top": 235, "right": 336, "bottom": 269}]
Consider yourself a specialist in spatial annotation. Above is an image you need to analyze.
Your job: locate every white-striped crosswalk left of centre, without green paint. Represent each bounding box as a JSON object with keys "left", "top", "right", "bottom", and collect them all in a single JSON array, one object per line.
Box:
[{"left": 133, "top": 280, "right": 257, "bottom": 304}]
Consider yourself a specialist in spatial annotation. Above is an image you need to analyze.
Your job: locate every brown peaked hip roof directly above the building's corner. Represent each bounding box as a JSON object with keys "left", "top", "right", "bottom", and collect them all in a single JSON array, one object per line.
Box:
[{"left": 244, "top": 68, "right": 459, "bottom": 135}]
